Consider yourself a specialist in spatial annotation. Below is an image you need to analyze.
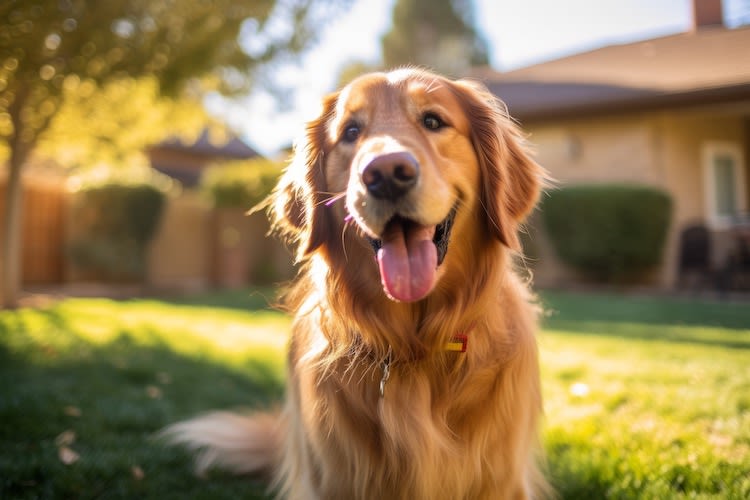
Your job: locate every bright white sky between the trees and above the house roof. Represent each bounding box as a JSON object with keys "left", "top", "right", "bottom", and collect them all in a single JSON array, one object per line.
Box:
[{"left": 208, "top": 0, "right": 743, "bottom": 156}]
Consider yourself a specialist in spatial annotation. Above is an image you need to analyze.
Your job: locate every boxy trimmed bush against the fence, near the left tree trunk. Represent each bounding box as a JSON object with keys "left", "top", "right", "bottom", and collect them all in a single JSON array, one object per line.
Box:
[{"left": 68, "top": 168, "right": 166, "bottom": 281}]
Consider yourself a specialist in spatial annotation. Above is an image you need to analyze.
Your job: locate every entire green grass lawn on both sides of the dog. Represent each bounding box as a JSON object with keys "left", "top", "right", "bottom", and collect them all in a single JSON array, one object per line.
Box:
[{"left": 0, "top": 290, "right": 750, "bottom": 500}]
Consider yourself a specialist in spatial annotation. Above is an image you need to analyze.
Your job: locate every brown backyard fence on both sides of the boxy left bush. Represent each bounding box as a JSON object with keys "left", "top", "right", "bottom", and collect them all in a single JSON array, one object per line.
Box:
[{"left": 0, "top": 178, "right": 294, "bottom": 291}]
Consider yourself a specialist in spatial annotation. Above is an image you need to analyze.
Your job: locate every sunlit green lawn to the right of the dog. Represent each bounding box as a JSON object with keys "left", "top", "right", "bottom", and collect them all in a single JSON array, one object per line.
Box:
[{"left": 541, "top": 294, "right": 750, "bottom": 499}]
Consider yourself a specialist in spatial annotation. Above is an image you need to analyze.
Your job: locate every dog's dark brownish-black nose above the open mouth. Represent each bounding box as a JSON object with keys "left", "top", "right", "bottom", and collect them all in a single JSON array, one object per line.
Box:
[{"left": 361, "top": 152, "right": 419, "bottom": 200}]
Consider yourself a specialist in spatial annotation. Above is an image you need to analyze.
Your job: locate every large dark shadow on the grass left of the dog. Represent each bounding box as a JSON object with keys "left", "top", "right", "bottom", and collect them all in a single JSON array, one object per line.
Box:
[{"left": 0, "top": 309, "right": 283, "bottom": 500}]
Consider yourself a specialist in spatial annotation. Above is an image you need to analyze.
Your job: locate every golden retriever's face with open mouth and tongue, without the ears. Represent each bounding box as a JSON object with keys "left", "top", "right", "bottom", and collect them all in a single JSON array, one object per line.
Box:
[{"left": 326, "top": 72, "right": 478, "bottom": 302}]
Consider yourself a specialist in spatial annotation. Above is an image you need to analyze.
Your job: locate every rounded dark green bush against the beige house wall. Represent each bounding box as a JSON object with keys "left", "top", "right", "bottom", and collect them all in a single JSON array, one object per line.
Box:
[{"left": 542, "top": 185, "right": 672, "bottom": 282}]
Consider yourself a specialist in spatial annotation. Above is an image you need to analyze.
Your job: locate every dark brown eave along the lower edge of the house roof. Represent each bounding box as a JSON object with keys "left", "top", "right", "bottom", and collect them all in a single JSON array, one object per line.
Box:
[{"left": 509, "top": 82, "right": 750, "bottom": 123}]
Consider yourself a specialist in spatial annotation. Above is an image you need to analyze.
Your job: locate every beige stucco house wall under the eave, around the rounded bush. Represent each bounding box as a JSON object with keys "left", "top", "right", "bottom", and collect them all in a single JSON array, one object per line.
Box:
[{"left": 524, "top": 109, "right": 748, "bottom": 288}]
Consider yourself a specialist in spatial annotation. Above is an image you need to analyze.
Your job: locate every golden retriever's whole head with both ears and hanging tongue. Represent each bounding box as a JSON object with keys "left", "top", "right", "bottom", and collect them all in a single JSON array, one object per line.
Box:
[{"left": 272, "top": 69, "right": 543, "bottom": 302}]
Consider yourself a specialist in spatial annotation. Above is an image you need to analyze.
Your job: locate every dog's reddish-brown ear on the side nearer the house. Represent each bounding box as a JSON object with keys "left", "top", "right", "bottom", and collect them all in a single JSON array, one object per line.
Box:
[{"left": 455, "top": 80, "right": 546, "bottom": 250}]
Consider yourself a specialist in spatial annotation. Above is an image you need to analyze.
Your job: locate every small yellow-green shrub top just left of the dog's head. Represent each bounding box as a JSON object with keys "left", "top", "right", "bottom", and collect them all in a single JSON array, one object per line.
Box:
[{"left": 200, "top": 158, "right": 281, "bottom": 209}]
